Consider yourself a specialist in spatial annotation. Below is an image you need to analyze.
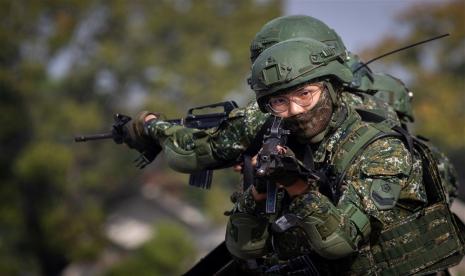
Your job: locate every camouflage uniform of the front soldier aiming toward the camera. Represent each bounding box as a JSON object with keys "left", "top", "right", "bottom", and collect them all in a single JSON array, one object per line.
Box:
[{"left": 230, "top": 100, "right": 427, "bottom": 274}]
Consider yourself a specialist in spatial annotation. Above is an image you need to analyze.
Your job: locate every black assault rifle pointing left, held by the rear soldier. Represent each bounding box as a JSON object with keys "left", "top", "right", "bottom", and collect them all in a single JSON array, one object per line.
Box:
[{"left": 74, "top": 101, "right": 238, "bottom": 189}]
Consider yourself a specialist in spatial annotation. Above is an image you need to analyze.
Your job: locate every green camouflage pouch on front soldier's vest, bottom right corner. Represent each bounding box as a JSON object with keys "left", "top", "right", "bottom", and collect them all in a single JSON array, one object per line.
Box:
[{"left": 341, "top": 202, "right": 465, "bottom": 275}]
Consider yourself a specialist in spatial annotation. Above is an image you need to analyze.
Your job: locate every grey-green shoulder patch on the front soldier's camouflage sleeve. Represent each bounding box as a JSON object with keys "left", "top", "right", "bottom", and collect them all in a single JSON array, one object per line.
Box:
[{"left": 370, "top": 179, "right": 401, "bottom": 210}]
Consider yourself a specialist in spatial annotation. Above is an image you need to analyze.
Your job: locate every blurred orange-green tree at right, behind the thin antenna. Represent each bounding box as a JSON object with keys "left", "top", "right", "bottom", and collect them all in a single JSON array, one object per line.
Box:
[{"left": 363, "top": 0, "right": 465, "bottom": 195}]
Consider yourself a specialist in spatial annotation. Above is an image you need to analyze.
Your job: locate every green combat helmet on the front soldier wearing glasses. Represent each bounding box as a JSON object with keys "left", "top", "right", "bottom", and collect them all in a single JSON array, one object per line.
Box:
[{"left": 250, "top": 38, "right": 353, "bottom": 112}]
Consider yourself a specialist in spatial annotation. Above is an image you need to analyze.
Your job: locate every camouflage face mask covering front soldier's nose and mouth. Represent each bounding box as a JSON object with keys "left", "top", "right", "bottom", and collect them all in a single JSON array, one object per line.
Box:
[{"left": 284, "top": 87, "right": 333, "bottom": 143}]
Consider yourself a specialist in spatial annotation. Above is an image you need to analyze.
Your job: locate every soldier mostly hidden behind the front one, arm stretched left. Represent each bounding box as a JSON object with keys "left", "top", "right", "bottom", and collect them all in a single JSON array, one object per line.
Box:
[{"left": 138, "top": 15, "right": 457, "bottom": 205}]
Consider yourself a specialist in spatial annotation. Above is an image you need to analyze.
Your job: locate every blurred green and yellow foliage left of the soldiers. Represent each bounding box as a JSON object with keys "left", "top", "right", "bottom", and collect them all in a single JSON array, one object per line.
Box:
[{"left": 0, "top": 0, "right": 281, "bottom": 275}]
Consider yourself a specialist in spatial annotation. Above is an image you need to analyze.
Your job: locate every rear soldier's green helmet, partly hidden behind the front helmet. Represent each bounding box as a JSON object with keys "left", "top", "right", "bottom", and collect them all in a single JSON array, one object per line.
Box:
[{"left": 250, "top": 15, "right": 347, "bottom": 63}]
